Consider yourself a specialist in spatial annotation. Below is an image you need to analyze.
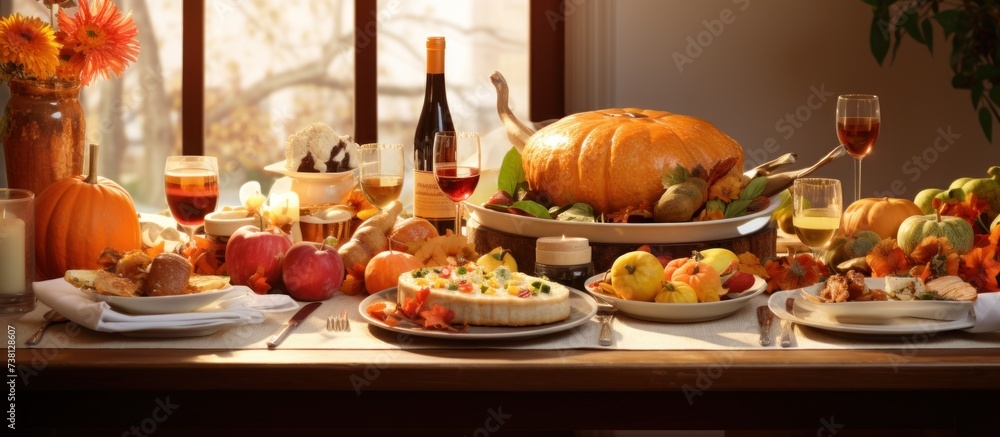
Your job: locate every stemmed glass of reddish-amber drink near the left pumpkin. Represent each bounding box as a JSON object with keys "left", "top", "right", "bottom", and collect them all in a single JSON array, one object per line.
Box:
[{"left": 163, "top": 156, "right": 219, "bottom": 244}]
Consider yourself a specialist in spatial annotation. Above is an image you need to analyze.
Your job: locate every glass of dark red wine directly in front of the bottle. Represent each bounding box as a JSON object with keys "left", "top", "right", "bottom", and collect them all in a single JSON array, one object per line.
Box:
[{"left": 434, "top": 131, "right": 480, "bottom": 235}]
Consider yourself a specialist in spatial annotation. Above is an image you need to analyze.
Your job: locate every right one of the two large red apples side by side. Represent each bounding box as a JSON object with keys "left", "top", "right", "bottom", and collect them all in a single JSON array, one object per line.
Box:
[{"left": 281, "top": 241, "right": 344, "bottom": 300}]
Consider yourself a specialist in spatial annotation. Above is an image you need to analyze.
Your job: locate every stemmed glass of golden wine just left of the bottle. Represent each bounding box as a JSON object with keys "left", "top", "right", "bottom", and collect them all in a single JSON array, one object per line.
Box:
[{"left": 358, "top": 143, "right": 403, "bottom": 211}]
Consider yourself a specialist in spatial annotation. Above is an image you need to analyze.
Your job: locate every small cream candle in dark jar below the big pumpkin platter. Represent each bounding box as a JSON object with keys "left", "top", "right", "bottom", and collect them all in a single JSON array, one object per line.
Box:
[{"left": 535, "top": 235, "right": 594, "bottom": 290}]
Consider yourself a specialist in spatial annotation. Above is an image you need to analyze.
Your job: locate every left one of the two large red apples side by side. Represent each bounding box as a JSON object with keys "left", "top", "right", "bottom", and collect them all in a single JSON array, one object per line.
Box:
[{"left": 226, "top": 225, "right": 292, "bottom": 293}]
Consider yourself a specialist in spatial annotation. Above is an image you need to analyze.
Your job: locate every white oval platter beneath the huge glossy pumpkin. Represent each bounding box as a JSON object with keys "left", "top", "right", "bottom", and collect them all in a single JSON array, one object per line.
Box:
[{"left": 465, "top": 196, "right": 780, "bottom": 244}]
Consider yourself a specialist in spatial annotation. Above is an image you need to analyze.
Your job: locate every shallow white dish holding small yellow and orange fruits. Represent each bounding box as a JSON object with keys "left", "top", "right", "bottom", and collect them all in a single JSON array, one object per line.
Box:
[{"left": 585, "top": 273, "right": 767, "bottom": 323}]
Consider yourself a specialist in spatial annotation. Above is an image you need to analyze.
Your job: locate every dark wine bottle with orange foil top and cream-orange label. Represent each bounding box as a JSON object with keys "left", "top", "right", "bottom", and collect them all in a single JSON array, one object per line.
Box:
[{"left": 413, "top": 36, "right": 455, "bottom": 235}]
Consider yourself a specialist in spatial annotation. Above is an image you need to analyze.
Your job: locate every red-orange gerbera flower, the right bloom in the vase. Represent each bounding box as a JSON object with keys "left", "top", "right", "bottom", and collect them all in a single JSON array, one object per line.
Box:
[{"left": 59, "top": 0, "right": 139, "bottom": 85}]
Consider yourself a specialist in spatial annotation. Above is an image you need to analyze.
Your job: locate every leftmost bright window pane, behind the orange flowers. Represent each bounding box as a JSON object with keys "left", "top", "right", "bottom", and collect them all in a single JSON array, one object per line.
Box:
[{"left": 5, "top": 0, "right": 182, "bottom": 212}]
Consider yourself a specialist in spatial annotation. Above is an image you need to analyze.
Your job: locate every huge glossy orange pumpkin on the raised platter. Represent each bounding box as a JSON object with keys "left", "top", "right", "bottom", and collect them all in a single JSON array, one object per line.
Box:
[{"left": 522, "top": 108, "right": 743, "bottom": 213}]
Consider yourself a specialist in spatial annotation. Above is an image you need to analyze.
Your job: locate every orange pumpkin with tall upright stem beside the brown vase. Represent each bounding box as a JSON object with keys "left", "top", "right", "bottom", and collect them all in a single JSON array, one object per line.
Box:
[{"left": 35, "top": 144, "right": 142, "bottom": 279}]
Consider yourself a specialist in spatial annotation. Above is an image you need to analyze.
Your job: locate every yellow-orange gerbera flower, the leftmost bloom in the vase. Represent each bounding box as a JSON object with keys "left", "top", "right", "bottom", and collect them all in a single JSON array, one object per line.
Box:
[{"left": 0, "top": 13, "right": 59, "bottom": 79}]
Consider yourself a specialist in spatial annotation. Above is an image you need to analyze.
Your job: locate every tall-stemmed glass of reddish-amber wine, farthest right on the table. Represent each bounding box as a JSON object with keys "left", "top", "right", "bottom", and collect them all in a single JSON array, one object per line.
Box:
[{"left": 837, "top": 94, "right": 882, "bottom": 200}]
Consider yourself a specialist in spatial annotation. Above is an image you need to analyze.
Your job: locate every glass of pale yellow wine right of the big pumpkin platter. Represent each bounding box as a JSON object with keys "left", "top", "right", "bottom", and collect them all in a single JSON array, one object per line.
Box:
[{"left": 792, "top": 178, "right": 844, "bottom": 256}]
